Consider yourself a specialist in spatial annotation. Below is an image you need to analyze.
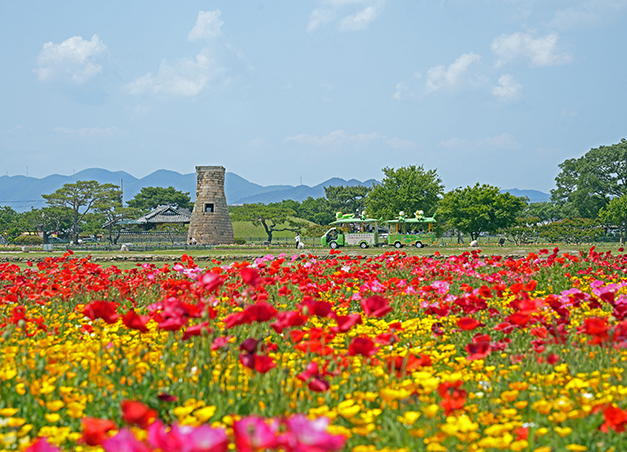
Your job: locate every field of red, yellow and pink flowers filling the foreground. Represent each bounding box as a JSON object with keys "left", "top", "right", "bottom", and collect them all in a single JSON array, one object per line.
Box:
[{"left": 0, "top": 248, "right": 627, "bottom": 452}]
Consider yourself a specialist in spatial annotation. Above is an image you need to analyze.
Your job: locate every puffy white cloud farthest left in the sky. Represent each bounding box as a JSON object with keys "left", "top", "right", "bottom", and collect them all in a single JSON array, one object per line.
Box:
[{"left": 35, "top": 35, "right": 107, "bottom": 85}]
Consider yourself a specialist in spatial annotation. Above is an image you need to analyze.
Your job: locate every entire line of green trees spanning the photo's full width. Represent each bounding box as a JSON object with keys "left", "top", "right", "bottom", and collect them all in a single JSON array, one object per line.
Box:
[{"left": 0, "top": 139, "right": 627, "bottom": 244}]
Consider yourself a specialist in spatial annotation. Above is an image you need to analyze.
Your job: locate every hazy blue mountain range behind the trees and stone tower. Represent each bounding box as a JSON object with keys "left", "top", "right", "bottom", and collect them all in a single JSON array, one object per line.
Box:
[{"left": 0, "top": 168, "right": 550, "bottom": 211}]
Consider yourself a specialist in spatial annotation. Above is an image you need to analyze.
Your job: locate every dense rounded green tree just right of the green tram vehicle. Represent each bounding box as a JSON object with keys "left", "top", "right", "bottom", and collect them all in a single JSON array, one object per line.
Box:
[{"left": 438, "top": 183, "right": 527, "bottom": 240}]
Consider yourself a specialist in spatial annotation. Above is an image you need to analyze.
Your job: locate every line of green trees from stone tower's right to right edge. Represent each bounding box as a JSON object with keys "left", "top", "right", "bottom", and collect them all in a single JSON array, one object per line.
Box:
[{"left": 230, "top": 139, "right": 627, "bottom": 244}]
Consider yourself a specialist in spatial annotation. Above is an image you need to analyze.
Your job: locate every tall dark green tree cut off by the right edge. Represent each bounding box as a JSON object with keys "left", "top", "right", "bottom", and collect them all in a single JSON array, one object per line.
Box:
[{"left": 551, "top": 138, "right": 627, "bottom": 218}]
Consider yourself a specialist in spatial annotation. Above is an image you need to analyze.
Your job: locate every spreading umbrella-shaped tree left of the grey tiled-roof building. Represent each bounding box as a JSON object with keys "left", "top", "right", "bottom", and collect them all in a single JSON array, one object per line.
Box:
[{"left": 42, "top": 180, "right": 122, "bottom": 243}]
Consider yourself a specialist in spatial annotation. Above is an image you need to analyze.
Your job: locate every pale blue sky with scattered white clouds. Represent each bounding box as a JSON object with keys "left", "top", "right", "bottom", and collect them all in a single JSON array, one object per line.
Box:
[{"left": 0, "top": 0, "right": 627, "bottom": 191}]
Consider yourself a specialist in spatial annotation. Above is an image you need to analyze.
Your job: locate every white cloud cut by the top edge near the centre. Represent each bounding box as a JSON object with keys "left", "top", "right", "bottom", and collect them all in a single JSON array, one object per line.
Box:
[{"left": 307, "top": 0, "right": 385, "bottom": 33}]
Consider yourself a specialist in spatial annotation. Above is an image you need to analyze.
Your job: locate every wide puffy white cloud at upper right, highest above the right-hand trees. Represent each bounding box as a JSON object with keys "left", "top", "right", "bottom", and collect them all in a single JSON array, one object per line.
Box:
[{"left": 491, "top": 32, "right": 572, "bottom": 67}]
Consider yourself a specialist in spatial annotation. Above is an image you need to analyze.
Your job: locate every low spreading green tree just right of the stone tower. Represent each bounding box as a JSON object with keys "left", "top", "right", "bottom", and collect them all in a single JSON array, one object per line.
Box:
[{"left": 229, "top": 203, "right": 305, "bottom": 242}]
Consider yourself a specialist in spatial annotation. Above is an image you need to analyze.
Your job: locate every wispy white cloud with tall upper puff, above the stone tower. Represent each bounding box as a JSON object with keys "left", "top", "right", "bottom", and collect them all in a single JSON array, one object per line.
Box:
[{"left": 125, "top": 10, "right": 253, "bottom": 97}]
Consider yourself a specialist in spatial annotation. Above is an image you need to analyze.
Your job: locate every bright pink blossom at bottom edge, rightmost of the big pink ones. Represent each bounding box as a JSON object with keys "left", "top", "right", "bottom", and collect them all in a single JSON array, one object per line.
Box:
[{"left": 281, "top": 414, "right": 346, "bottom": 452}]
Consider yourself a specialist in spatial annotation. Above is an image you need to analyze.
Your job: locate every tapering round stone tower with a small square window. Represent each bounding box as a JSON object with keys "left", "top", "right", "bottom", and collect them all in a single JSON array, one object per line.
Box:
[{"left": 187, "top": 166, "right": 233, "bottom": 245}]
